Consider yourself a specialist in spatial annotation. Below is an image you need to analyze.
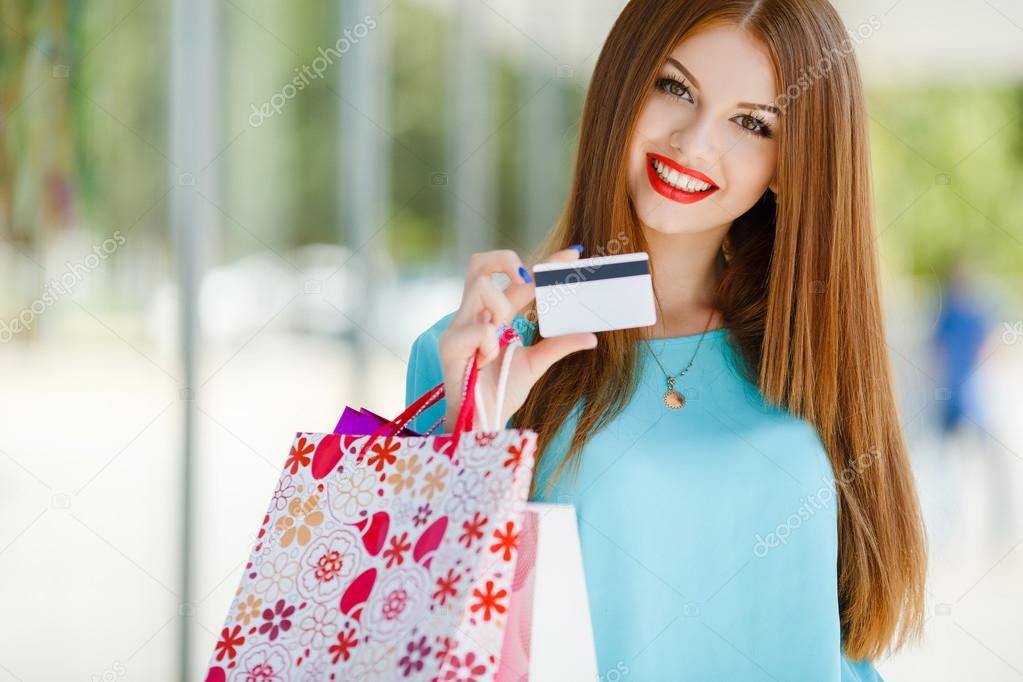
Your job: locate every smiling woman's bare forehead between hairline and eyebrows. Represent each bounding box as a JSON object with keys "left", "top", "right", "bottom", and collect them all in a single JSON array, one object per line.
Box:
[{"left": 671, "top": 26, "right": 779, "bottom": 103}]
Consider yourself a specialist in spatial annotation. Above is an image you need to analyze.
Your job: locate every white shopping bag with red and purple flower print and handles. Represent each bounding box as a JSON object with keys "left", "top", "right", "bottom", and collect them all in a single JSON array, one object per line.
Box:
[{"left": 207, "top": 329, "right": 537, "bottom": 682}]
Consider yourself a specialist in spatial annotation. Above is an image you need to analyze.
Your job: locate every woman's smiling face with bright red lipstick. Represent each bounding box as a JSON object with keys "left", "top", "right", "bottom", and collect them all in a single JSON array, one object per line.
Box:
[{"left": 628, "top": 26, "right": 781, "bottom": 233}]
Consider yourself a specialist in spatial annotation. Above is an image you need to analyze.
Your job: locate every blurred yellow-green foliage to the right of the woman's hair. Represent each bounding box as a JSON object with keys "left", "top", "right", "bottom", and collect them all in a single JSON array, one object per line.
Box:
[{"left": 869, "top": 86, "right": 1023, "bottom": 277}]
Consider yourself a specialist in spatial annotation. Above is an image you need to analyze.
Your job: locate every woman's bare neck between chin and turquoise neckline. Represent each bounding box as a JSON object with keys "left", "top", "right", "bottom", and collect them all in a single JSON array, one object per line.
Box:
[{"left": 643, "top": 225, "right": 730, "bottom": 338}]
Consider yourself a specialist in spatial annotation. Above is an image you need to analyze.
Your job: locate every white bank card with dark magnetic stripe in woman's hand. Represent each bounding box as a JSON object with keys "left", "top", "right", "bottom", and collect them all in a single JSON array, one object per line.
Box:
[{"left": 533, "top": 252, "right": 657, "bottom": 336}]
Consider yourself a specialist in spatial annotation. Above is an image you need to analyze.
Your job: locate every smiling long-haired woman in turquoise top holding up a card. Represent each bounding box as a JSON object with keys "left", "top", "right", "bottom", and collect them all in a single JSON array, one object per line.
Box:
[{"left": 406, "top": 0, "right": 926, "bottom": 682}]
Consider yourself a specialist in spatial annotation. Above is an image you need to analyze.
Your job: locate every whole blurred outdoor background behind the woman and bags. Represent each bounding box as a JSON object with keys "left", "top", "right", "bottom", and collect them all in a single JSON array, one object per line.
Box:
[{"left": 0, "top": 0, "right": 1023, "bottom": 682}]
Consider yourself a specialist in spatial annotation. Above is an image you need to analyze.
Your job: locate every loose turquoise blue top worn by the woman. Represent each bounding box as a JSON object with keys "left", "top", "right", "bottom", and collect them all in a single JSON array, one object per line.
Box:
[{"left": 405, "top": 312, "right": 882, "bottom": 682}]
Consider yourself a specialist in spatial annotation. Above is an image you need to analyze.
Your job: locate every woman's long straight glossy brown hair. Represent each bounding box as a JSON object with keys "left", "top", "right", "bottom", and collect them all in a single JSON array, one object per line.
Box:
[{"left": 513, "top": 0, "right": 926, "bottom": 660}]
